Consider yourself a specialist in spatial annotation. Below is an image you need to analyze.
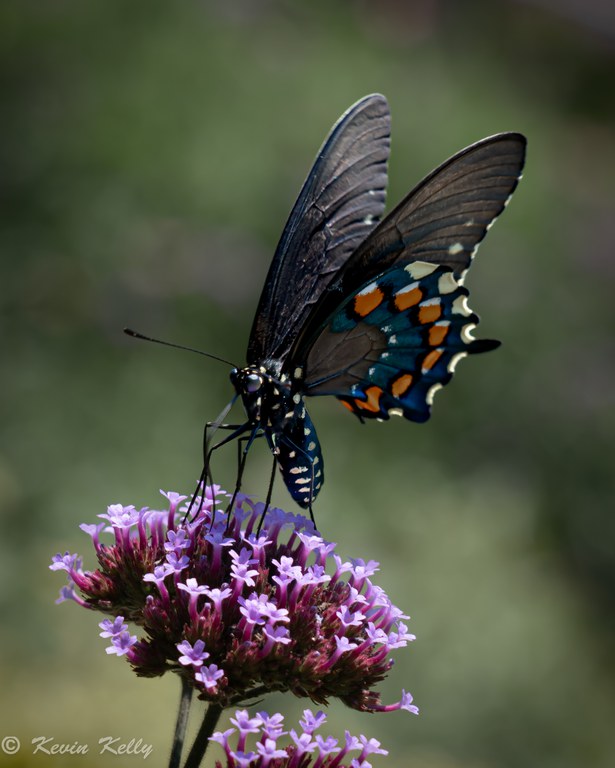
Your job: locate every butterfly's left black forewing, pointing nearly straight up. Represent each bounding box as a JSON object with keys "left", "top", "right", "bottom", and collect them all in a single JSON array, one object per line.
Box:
[{"left": 247, "top": 94, "right": 390, "bottom": 364}]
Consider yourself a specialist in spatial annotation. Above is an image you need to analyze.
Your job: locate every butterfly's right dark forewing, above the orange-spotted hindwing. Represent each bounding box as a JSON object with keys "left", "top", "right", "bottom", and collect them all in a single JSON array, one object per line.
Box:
[{"left": 290, "top": 133, "right": 526, "bottom": 380}]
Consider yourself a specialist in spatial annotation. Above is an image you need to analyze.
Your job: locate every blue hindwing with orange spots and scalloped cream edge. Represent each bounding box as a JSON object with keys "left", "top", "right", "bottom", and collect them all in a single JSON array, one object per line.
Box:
[{"left": 304, "top": 261, "right": 499, "bottom": 422}]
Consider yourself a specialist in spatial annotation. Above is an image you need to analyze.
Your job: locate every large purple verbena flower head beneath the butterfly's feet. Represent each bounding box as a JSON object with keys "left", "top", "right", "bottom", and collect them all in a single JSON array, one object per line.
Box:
[{"left": 50, "top": 486, "right": 417, "bottom": 713}]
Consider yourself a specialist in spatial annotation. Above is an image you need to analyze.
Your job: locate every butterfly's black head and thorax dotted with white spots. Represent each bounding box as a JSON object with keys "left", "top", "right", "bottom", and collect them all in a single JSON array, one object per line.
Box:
[{"left": 231, "top": 364, "right": 297, "bottom": 432}]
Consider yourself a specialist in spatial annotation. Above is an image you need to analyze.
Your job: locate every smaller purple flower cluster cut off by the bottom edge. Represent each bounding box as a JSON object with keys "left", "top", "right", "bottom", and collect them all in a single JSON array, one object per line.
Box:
[{"left": 210, "top": 709, "right": 388, "bottom": 768}]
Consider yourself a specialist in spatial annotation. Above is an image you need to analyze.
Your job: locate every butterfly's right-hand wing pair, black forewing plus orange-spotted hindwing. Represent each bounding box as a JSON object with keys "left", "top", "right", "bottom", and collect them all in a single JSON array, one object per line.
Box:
[{"left": 289, "top": 133, "right": 525, "bottom": 421}]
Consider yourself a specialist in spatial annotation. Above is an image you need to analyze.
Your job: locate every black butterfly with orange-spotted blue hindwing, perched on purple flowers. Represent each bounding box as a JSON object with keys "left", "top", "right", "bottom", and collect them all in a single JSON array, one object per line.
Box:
[{"left": 223, "top": 94, "right": 526, "bottom": 513}]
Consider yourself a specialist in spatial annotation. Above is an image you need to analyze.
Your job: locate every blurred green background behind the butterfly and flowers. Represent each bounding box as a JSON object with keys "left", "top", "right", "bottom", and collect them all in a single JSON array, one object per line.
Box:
[{"left": 0, "top": 0, "right": 615, "bottom": 768}]
